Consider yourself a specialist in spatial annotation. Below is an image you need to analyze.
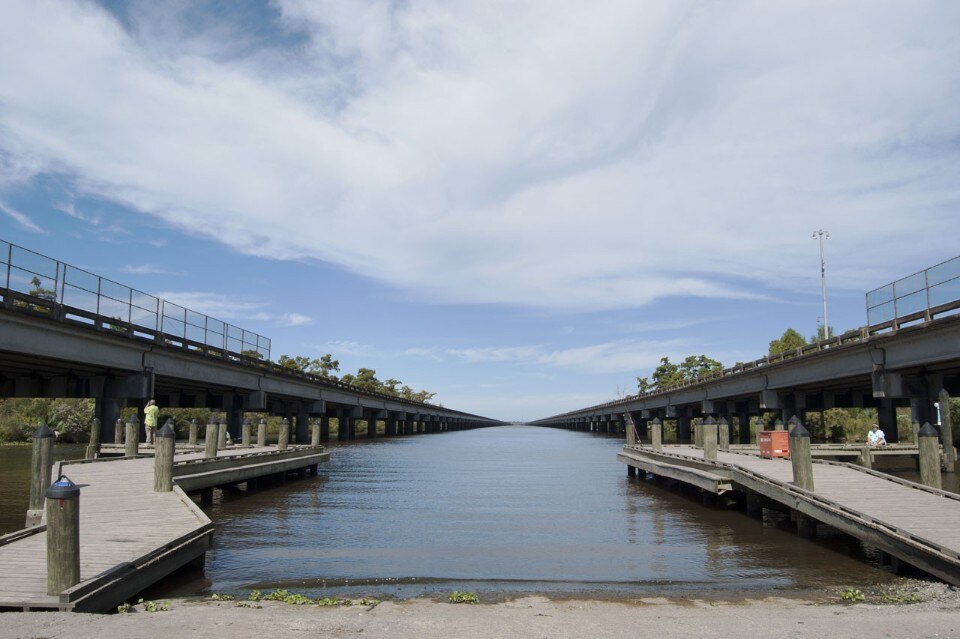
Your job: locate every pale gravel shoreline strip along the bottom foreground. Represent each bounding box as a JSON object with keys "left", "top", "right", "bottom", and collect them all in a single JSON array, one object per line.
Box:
[{"left": 0, "top": 580, "right": 960, "bottom": 639}]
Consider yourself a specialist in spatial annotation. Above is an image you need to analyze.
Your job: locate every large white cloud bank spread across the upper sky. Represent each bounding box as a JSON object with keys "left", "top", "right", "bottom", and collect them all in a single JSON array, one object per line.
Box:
[{"left": 0, "top": 0, "right": 960, "bottom": 310}]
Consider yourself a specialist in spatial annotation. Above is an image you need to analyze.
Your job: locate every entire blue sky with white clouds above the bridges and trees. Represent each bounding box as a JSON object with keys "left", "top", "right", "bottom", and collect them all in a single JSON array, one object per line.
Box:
[{"left": 0, "top": 0, "right": 960, "bottom": 420}]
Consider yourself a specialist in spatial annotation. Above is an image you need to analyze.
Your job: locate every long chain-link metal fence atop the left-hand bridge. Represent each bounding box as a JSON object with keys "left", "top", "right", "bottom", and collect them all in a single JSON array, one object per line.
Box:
[{"left": 0, "top": 240, "right": 270, "bottom": 361}]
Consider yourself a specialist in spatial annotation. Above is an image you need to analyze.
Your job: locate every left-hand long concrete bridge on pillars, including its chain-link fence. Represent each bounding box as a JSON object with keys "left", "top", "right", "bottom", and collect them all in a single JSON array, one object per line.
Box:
[{"left": 0, "top": 241, "right": 501, "bottom": 444}]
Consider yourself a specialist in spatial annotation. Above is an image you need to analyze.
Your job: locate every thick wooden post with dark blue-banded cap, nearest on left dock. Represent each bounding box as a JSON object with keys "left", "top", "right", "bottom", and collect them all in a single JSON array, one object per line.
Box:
[{"left": 46, "top": 475, "right": 80, "bottom": 596}]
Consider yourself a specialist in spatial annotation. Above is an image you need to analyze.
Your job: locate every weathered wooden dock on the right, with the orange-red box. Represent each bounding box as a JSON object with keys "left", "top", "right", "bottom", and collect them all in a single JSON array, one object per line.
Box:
[{"left": 618, "top": 445, "right": 960, "bottom": 585}]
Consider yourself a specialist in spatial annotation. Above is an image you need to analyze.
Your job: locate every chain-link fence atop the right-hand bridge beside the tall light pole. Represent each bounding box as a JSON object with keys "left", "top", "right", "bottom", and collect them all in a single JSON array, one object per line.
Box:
[{"left": 866, "top": 257, "right": 960, "bottom": 326}]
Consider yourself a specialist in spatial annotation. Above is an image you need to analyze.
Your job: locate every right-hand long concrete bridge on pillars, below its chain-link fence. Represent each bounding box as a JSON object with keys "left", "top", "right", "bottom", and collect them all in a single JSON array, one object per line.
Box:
[{"left": 531, "top": 301, "right": 960, "bottom": 446}]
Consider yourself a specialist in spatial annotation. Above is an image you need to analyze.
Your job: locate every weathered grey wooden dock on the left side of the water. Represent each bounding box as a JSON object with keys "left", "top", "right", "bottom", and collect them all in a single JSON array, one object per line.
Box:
[{"left": 0, "top": 446, "right": 330, "bottom": 612}]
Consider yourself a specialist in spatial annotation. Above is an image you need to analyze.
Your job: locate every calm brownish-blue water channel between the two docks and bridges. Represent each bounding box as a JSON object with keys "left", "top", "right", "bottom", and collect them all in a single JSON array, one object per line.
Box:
[{"left": 0, "top": 426, "right": 944, "bottom": 598}]
